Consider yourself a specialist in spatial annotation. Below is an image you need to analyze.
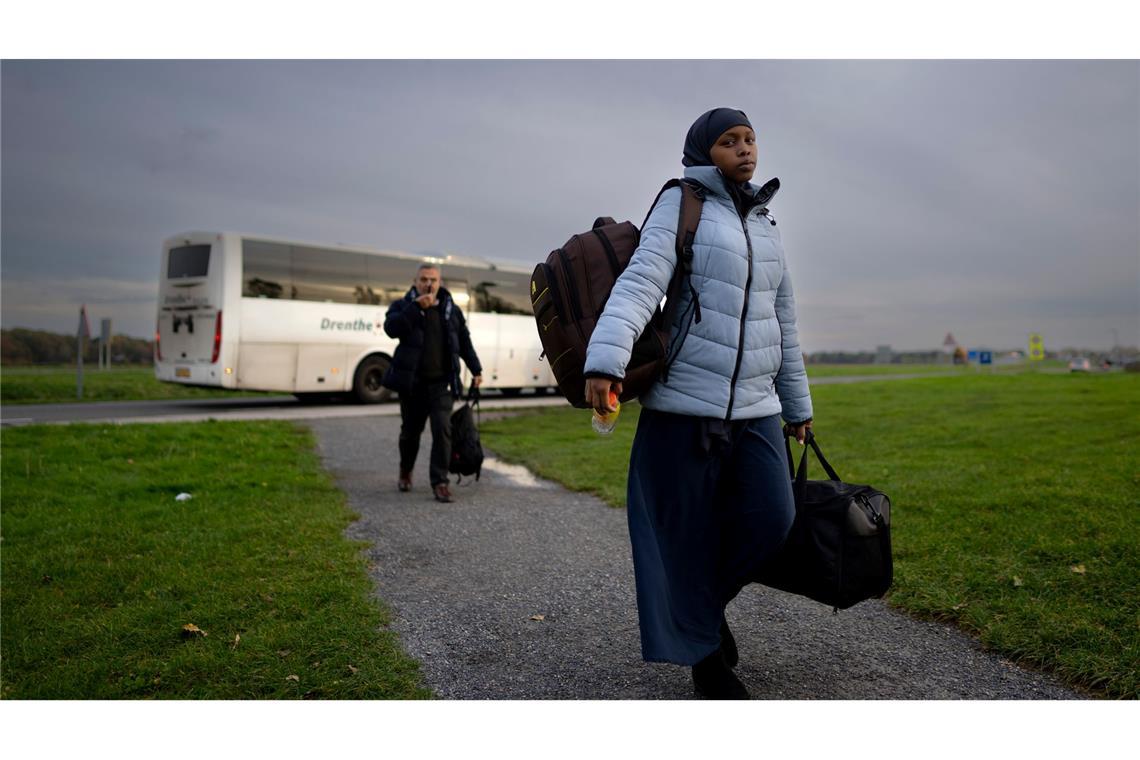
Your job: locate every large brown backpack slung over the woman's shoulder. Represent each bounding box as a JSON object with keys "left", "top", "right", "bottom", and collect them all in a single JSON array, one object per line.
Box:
[{"left": 530, "top": 179, "right": 705, "bottom": 409}]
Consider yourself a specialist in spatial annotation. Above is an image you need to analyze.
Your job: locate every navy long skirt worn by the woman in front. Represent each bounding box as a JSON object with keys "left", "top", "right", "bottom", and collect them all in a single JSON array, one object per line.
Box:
[{"left": 627, "top": 409, "right": 796, "bottom": 665}]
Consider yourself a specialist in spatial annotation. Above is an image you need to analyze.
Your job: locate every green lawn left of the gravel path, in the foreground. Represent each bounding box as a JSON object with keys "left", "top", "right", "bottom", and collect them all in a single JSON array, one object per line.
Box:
[{"left": 0, "top": 422, "right": 430, "bottom": 700}]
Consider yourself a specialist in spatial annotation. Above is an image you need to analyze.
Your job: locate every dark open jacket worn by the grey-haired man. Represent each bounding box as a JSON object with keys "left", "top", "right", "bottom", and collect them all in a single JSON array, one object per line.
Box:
[{"left": 382, "top": 287, "right": 483, "bottom": 398}]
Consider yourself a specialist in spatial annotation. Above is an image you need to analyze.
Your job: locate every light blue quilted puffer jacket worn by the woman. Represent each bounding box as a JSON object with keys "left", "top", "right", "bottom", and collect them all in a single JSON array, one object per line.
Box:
[{"left": 585, "top": 166, "right": 812, "bottom": 423}]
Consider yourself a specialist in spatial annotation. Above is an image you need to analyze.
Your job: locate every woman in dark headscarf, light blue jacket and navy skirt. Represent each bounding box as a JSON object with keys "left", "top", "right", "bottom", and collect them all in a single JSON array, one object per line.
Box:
[{"left": 586, "top": 108, "right": 812, "bottom": 698}]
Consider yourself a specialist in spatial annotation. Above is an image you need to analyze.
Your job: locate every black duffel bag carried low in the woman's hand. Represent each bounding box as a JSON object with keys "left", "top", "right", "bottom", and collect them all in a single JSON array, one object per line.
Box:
[{"left": 757, "top": 430, "right": 894, "bottom": 610}]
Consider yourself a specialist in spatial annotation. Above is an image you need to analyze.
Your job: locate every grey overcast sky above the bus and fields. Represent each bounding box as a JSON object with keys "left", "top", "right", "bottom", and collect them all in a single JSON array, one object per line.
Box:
[{"left": 0, "top": 60, "right": 1140, "bottom": 352}]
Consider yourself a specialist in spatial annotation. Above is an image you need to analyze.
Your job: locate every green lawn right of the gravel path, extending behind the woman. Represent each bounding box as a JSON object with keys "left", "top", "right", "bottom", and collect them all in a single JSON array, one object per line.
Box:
[{"left": 482, "top": 373, "right": 1140, "bottom": 698}]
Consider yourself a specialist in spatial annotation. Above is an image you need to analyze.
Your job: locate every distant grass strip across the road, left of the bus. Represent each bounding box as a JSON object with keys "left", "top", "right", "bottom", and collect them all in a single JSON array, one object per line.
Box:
[{"left": 0, "top": 365, "right": 271, "bottom": 403}]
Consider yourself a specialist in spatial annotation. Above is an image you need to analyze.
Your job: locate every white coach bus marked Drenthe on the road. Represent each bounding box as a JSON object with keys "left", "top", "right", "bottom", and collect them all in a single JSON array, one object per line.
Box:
[{"left": 154, "top": 232, "right": 555, "bottom": 403}]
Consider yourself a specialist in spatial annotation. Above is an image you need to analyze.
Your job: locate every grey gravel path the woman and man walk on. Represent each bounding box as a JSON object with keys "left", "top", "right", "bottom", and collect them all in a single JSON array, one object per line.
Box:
[{"left": 306, "top": 417, "right": 1081, "bottom": 700}]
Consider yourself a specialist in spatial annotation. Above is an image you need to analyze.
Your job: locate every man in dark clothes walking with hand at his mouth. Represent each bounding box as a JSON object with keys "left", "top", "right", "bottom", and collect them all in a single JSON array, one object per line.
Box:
[{"left": 383, "top": 263, "right": 483, "bottom": 502}]
